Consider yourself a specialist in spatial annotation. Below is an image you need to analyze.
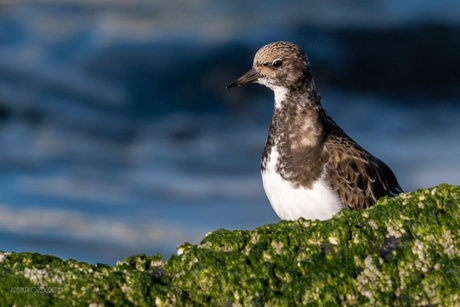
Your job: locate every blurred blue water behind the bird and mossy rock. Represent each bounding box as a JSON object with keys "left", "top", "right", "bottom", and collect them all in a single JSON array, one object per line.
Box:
[{"left": 0, "top": 0, "right": 460, "bottom": 264}]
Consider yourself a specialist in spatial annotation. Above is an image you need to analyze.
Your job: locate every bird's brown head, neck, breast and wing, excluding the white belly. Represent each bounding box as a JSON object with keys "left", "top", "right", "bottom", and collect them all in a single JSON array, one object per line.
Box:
[{"left": 228, "top": 42, "right": 402, "bottom": 217}]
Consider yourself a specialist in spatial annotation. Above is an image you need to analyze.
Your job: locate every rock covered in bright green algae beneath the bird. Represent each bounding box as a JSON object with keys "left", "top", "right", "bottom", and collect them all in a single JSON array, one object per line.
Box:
[{"left": 0, "top": 184, "right": 460, "bottom": 306}]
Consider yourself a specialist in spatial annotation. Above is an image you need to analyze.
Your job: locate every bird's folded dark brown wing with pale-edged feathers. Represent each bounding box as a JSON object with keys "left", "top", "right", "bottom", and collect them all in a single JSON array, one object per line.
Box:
[{"left": 323, "top": 131, "right": 402, "bottom": 210}]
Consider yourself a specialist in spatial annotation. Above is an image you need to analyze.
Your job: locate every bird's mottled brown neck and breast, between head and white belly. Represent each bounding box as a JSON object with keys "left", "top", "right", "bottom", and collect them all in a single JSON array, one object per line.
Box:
[{"left": 262, "top": 84, "right": 325, "bottom": 188}]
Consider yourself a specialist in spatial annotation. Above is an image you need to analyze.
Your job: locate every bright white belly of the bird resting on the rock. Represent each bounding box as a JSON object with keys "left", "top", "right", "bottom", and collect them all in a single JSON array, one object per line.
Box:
[{"left": 262, "top": 146, "right": 345, "bottom": 220}]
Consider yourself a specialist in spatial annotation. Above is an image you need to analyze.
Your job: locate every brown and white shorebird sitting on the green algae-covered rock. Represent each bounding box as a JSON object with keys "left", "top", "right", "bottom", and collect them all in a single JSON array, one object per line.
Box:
[{"left": 227, "top": 41, "right": 403, "bottom": 220}]
